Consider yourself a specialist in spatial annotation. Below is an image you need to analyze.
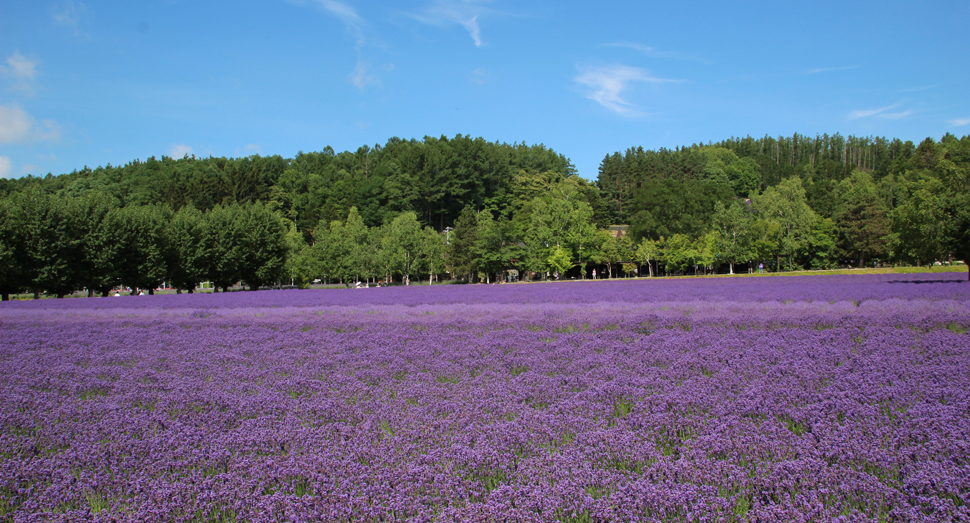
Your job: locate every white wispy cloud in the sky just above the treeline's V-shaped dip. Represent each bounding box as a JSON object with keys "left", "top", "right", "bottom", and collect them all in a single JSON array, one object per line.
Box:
[{"left": 573, "top": 65, "right": 677, "bottom": 116}]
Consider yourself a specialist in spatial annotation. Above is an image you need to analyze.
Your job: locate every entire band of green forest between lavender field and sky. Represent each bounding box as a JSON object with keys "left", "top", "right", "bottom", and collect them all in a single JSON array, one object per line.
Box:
[{"left": 0, "top": 134, "right": 970, "bottom": 300}]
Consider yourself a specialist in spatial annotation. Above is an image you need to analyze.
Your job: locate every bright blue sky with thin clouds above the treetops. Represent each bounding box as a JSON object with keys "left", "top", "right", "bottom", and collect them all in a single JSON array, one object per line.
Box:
[{"left": 0, "top": 0, "right": 970, "bottom": 179}]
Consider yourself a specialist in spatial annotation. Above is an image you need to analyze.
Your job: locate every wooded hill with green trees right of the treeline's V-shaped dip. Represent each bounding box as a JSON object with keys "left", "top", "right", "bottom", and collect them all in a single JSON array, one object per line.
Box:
[{"left": 597, "top": 134, "right": 970, "bottom": 269}]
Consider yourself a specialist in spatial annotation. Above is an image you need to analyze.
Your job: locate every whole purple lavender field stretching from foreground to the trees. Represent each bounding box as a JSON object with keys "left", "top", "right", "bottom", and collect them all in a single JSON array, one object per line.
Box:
[{"left": 0, "top": 273, "right": 970, "bottom": 522}]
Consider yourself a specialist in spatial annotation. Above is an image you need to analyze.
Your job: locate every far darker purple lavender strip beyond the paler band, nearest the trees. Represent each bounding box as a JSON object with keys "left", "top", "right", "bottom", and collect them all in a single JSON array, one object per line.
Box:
[{"left": 0, "top": 273, "right": 970, "bottom": 313}]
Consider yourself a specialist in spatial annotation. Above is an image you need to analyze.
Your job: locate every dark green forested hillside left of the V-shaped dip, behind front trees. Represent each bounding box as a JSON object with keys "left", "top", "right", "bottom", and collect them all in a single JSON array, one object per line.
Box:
[{"left": 0, "top": 135, "right": 575, "bottom": 230}]
